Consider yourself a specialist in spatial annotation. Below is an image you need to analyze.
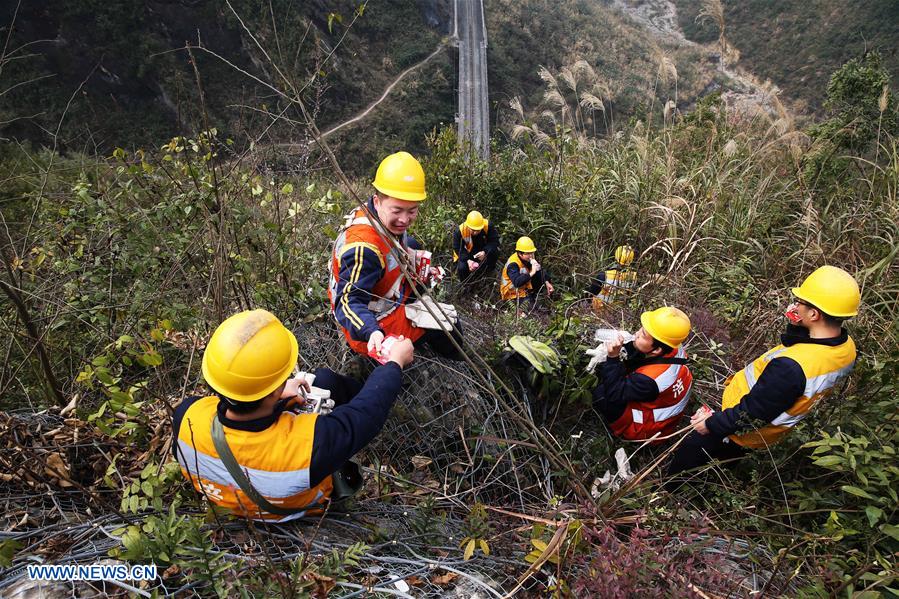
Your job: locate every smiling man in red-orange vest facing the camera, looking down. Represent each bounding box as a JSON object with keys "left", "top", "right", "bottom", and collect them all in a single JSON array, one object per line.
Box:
[{"left": 328, "top": 152, "right": 462, "bottom": 359}]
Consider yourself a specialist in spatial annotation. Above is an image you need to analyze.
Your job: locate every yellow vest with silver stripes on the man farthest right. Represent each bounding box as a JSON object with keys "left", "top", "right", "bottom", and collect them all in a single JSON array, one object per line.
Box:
[{"left": 721, "top": 337, "right": 856, "bottom": 449}]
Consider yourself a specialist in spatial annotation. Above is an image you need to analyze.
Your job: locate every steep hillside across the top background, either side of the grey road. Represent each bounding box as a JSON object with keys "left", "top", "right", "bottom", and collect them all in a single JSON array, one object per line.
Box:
[{"left": 0, "top": 0, "right": 899, "bottom": 162}]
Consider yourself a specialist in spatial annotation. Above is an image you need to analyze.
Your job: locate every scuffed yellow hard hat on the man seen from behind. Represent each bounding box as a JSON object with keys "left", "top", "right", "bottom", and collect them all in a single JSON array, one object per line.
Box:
[{"left": 202, "top": 310, "right": 299, "bottom": 401}]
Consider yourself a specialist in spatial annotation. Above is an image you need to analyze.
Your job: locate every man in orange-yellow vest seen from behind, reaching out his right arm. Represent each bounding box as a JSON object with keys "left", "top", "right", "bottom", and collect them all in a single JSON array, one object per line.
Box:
[{"left": 172, "top": 310, "right": 413, "bottom": 522}]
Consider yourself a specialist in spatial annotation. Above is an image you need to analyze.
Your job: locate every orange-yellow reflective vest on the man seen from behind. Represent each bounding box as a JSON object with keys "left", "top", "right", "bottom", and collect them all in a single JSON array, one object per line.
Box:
[{"left": 176, "top": 396, "right": 332, "bottom": 522}]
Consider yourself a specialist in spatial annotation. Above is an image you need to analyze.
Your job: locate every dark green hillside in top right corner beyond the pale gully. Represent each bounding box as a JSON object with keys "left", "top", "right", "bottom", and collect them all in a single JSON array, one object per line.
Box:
[{"left": 674, "top": 0, "right": 899, "bottom": 112}]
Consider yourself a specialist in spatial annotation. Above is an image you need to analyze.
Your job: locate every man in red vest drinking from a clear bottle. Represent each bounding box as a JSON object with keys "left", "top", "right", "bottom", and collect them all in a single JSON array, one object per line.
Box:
[{"left": 588, "top": 307, "right": 693, "bottom": 440}]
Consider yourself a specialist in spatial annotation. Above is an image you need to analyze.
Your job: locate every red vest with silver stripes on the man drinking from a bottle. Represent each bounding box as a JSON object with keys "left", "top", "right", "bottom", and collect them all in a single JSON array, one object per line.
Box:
[{"left": 611, "top": 347, "right": 693, "bottom": 440}]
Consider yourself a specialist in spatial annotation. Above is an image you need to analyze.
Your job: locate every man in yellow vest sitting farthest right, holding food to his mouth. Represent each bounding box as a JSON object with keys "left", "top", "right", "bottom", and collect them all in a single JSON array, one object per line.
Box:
[{"left": 668, "top": 266, "right": 861, "bottom": 474}]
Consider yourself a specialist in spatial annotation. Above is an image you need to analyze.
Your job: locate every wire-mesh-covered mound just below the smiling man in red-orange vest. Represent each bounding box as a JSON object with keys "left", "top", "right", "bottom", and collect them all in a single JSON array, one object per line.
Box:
[{"left": 297, "top": 319, "right": 552, "bottom": 504}]
